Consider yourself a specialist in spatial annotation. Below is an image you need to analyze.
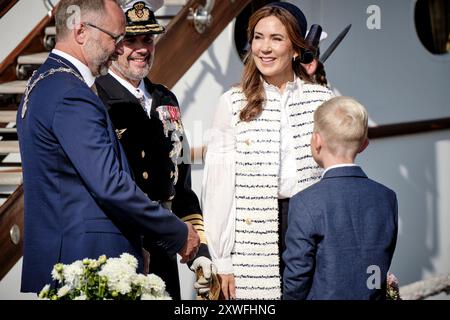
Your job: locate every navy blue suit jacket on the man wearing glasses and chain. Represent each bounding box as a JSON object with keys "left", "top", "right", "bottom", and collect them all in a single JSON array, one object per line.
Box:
[{"left": 17, "top": 54, "right": 187, "bottom": 292}]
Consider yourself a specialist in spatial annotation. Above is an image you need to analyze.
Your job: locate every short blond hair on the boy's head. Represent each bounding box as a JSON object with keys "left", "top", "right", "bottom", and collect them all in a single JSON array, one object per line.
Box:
[{"left": 314, "top": 96, "right": 369, "bottom": 156}]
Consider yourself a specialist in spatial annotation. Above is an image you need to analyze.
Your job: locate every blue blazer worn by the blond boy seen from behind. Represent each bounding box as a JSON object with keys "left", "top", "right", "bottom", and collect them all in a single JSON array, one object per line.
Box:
[{"left": 283, "top": 166, "right": 397, "bottom": 300}]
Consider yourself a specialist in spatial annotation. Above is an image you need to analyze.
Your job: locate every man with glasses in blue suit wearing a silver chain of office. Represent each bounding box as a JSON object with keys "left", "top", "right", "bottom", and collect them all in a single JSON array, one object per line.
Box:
[{"left": 17, "top": 0, "right": 199, "bottom": 292}]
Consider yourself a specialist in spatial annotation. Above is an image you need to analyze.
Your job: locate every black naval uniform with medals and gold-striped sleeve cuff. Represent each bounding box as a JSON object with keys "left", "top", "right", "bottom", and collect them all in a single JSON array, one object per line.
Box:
[{"left": 96, "top": 74, "right": 209, "bottom": 299}]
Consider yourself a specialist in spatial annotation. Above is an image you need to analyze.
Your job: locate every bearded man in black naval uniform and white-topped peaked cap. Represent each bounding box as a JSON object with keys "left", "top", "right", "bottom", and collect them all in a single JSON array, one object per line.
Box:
[{"left": 96, "top": 0, "right": 214, "bottom": 299}]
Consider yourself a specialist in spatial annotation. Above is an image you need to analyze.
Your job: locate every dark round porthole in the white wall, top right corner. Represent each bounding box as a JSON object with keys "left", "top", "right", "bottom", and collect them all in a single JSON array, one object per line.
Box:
[{"left": 414, "top": 0, "right": 450, "bottom": 54}]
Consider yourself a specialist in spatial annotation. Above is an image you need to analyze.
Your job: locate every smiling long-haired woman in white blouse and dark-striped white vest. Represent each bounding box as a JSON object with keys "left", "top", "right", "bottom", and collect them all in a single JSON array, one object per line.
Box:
[{"left": 202, "top": 2, "right": 332, "bottom": 299}]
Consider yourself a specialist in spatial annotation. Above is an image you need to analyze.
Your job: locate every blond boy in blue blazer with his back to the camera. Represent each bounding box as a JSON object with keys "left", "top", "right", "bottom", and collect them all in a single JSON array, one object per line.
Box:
[{"left": 283, "top": 97, "right": 397, "bottom": 300}]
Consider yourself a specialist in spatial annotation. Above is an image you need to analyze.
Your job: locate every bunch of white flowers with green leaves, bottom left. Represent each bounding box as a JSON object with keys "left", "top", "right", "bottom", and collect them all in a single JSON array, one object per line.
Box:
[{"left": 39, "top": 253, "right": 171, "bottom": 300}]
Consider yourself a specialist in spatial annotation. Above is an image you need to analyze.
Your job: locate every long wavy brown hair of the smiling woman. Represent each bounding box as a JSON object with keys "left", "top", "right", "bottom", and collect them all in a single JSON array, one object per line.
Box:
[{"left": 239, "top": 6, "right": 312, "bottom": 122}]
